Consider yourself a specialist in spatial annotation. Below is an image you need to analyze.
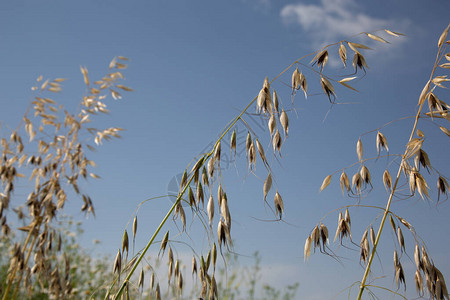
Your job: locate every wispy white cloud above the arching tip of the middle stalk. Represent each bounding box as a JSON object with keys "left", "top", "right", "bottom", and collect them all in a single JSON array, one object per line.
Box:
[{"left": 280, "top": 0, "right": 408, "bottom": 48}]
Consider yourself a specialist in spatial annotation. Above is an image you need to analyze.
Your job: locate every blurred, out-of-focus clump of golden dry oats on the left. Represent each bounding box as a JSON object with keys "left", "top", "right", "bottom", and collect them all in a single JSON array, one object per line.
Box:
[{"left": 0, "top": 57, "right": 131, "bottom": 300}]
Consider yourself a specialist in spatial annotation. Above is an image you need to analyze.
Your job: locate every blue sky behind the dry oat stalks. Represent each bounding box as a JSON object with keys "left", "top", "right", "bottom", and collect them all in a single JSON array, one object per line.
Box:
[{"left": 0, "top": 0, "right": 450, "bottom": 299}]
